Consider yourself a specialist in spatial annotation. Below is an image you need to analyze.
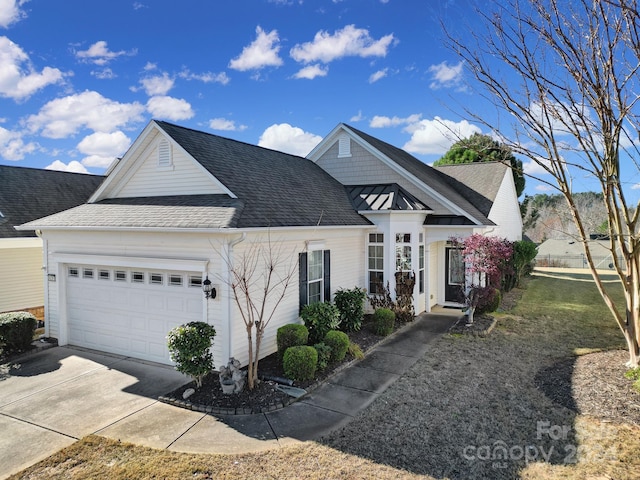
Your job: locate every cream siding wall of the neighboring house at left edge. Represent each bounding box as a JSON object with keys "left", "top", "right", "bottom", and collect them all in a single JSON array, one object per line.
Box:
[{"left": 0, "top": 238, "right": 44, "bottom": 312}]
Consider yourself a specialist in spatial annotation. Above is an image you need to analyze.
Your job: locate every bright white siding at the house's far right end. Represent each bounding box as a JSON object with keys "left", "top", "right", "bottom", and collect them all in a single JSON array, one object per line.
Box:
[{"left": 488, "top": 169, "right": 522, "bottom": 242}]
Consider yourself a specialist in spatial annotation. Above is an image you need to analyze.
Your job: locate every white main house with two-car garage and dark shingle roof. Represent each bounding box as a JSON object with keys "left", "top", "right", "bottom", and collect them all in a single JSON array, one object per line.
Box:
[{"left": 20, "top": 121, "right": 522, "bottom": 366}]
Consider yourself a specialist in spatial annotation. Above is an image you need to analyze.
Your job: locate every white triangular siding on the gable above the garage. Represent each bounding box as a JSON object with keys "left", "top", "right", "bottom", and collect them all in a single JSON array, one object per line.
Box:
[{"left": 112, "top": 143, "right": 225, "bottom": 197}]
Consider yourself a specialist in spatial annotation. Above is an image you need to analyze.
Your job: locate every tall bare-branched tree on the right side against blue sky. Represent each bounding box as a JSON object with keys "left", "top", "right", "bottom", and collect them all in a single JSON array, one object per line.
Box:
[{"left": 448, "top": 0, "right": 640, "bottom": 367}]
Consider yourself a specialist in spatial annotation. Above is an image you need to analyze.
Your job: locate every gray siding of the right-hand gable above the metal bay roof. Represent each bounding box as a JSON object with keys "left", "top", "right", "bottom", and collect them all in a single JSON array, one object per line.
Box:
[{"left": 316, "top": 141, "right": 451, "bottom": 214}]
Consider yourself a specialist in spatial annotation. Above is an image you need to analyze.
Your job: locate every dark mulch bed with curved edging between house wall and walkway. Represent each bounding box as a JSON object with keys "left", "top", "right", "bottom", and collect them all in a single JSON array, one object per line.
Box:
[{"left": 160, "top": 316, "right": 403, "bottom": 415}]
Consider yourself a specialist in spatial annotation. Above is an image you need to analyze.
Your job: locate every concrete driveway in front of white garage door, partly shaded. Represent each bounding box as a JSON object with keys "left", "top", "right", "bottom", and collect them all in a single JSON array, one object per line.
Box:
[{"left": 0, "top": 347, "right": 189, "bottom": 478}]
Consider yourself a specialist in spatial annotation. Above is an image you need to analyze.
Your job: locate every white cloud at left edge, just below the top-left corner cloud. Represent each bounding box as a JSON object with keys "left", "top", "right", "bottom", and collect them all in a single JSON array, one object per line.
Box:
[{"left": 0, "top": 36, "right": 64, "bottom": 100}]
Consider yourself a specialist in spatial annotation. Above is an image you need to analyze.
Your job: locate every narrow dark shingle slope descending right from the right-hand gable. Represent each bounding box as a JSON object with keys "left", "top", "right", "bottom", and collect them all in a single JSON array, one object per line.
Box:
[{"left": 345, "top": 125, "right": 494, "bottom": 225}]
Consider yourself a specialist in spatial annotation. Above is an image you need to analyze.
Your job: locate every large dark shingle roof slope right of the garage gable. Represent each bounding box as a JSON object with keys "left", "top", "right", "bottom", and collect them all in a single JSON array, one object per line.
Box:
[{"left": 156, "top": 121, "right": 370, "bottom": 228}]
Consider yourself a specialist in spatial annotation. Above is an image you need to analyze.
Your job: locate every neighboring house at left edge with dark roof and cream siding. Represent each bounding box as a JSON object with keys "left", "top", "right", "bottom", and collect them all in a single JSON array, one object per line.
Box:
[{"left": 0, "top": 165, "right": 104, "bottom": 319}]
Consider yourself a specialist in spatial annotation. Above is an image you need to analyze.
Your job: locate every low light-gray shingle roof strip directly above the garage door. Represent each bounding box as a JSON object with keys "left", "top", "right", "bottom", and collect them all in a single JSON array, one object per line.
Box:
[{"left": 21, "top": 195, "right": 243, "bottom": 228}]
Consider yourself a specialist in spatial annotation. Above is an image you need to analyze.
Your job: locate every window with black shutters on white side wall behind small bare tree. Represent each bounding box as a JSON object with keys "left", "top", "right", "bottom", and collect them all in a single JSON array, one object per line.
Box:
[{"left": 298, "top": 250, "right": 331, "bottom": 309}]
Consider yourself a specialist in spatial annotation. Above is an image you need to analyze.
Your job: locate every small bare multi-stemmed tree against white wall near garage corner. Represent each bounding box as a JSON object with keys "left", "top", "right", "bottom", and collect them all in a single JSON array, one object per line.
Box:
[{"left": 223, "top": 237, "right": 298, "bottom": 390}]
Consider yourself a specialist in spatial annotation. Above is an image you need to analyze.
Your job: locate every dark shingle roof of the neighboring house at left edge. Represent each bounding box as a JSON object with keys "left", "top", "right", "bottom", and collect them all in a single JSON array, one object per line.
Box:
[{"left": 0, "top": 165, "right": 104, "bottom": 238}]
